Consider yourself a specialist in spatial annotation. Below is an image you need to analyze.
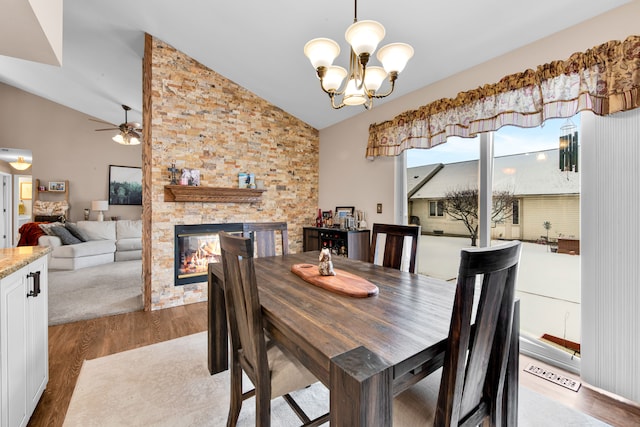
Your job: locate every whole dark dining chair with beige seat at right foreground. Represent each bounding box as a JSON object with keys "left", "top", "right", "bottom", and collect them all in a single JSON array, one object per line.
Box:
[{"left": 393, "top": 241, "right": 520, "bottom": 427}]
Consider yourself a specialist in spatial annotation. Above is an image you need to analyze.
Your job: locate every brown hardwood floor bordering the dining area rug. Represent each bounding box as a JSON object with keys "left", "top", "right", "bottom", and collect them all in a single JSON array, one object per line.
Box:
[{"left": 28, "top": 302, "right": 640, "bottom": 427}]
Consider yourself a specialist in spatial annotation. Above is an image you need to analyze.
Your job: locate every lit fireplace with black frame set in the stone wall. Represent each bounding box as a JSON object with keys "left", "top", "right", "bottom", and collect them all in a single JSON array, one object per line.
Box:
[{"left": 174, "top": 223, "right": 242, "bottom": 286}]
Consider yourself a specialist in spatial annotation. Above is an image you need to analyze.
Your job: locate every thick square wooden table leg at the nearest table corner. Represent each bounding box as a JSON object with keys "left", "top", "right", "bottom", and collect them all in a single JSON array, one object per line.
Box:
[{"left": 330, "top": 347, "right": 393, "bottom": 427}]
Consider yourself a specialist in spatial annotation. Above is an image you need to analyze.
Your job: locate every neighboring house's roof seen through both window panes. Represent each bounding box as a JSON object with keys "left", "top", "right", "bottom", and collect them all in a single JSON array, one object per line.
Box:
[{"left": 407, "top": 149, "right": 580, "bottom": 199}]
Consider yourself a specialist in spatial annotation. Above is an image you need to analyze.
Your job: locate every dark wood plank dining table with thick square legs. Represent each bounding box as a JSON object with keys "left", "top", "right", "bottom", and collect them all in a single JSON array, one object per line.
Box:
[{"left": 208, "top": 252, "right": 519, "bottom": 427}]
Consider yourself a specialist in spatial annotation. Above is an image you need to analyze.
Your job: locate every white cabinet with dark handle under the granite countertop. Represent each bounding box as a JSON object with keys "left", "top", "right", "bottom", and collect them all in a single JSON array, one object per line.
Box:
[{"left": 0, "top": 256, "right": 49, "bottom": 427}]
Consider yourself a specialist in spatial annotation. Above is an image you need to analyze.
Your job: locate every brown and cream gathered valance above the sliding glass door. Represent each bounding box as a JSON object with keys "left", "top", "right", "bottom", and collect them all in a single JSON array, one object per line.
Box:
[{"left": 366, "top": 35, "right": 640, "bottom": 157}]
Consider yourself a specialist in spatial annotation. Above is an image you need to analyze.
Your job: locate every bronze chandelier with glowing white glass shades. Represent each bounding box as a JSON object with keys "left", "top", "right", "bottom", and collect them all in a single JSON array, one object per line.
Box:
[{"left": 304, "top": 0, "right": 413, "bottom": 110}]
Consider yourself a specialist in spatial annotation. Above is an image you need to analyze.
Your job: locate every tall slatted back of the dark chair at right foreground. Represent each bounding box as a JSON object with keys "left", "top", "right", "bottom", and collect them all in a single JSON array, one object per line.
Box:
[{"left": 435, "top": 242, "right": 521, "bottom": 426}]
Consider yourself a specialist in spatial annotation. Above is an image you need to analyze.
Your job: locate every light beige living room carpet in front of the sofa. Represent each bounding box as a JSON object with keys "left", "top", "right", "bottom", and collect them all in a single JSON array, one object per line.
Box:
[{"left": 49, "top": 260, "right": 143, "bottom": 326}]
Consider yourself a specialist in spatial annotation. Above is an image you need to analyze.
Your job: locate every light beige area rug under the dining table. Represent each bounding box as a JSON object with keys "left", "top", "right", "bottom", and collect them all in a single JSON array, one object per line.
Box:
[{"left": 64, "top": 332, "right": 607, "bottom": 427}]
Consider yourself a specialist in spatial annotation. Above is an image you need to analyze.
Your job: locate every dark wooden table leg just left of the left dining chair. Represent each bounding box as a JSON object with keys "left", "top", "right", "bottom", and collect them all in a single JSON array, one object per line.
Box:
[{"left": 207, "top": 264, "right": 229, "bottom": 375}]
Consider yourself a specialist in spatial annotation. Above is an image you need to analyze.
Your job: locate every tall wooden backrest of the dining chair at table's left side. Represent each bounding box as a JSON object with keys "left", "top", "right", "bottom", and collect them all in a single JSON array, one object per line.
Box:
[{"left": 219, "top": 232, "right": 268, "bottom": 378}]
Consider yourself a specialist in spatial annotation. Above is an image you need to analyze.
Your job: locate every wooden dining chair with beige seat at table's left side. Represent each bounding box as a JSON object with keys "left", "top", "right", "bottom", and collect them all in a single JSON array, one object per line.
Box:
[{"left": 219, "top": 232, "right": 329, "bottom": 427}]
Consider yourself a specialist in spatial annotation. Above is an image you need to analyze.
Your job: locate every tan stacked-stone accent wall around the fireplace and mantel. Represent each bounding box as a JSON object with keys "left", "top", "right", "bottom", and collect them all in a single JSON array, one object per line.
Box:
[{"left": 149, "top": 38, "right": 319, "bottom": 310}]
